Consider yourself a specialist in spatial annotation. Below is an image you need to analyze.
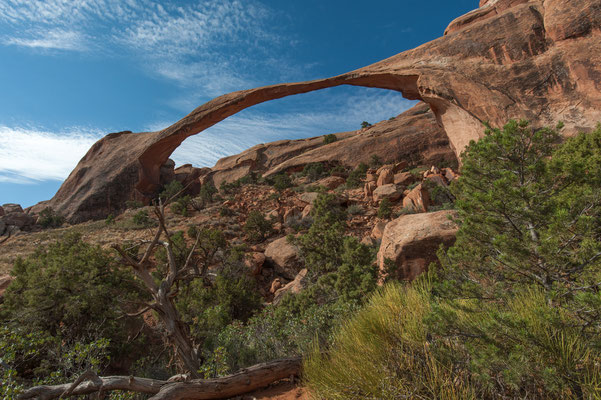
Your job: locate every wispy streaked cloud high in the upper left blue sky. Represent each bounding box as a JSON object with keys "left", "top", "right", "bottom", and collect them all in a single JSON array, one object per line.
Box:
[{"left": 0, "top": 0, "right": 290, "bottom": 95}]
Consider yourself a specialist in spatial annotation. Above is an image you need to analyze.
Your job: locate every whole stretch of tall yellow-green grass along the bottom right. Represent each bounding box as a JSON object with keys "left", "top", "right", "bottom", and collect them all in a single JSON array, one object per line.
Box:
[{"left": 304, "top": 279, "right": 601, "bottom": 400}]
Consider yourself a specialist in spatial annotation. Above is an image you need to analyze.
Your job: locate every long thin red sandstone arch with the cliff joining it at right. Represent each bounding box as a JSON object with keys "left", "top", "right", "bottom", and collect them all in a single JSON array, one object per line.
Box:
[{"left": 32, "top": 0, "right": 601, "bottom": 222}]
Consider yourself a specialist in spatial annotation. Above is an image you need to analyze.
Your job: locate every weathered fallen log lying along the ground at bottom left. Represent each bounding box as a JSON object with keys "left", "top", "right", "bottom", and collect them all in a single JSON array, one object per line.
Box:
[{"left": 18, "top": 357, "right": 301, "bottom": 400}]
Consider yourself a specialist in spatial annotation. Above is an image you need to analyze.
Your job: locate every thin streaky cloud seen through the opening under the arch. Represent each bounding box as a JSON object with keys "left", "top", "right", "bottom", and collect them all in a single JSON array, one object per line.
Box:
[{"left": 169, "top": 88, "right": 415, "bottom": 167}]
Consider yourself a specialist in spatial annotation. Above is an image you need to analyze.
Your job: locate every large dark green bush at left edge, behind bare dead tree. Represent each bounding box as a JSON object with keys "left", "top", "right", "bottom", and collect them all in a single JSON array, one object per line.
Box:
[{"left": 0, "top": 235, "right": 144, "bottom": 381}]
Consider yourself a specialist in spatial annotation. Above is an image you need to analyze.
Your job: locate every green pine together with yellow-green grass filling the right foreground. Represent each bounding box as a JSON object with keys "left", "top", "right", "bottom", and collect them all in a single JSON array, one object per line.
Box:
[{"left": 305, "top": 121, "right": 601, "bottom": 399}]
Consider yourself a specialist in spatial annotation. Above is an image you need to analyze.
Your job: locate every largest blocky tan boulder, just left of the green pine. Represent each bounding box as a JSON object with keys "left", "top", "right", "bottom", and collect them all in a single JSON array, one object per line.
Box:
[{"left": 378, "top": 210, "right": 457, "bottom": 280}]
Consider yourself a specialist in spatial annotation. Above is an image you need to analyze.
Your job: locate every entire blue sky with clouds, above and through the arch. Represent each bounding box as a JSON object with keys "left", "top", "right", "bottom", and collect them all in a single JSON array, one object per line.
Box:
[{"left": 0, "top": 0, "right": 478, "bottom": 206}]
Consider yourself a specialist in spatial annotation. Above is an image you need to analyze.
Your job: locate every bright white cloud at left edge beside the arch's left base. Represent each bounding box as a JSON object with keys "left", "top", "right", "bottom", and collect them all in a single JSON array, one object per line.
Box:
[{"left": 0, "top": 126, "right": 103, "bottom": 183}]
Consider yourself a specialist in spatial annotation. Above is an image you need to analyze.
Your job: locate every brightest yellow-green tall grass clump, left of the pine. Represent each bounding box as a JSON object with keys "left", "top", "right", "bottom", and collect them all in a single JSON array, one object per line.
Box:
[{"left": 304, "top": 281, "right": 476, "bottom": 400}]
